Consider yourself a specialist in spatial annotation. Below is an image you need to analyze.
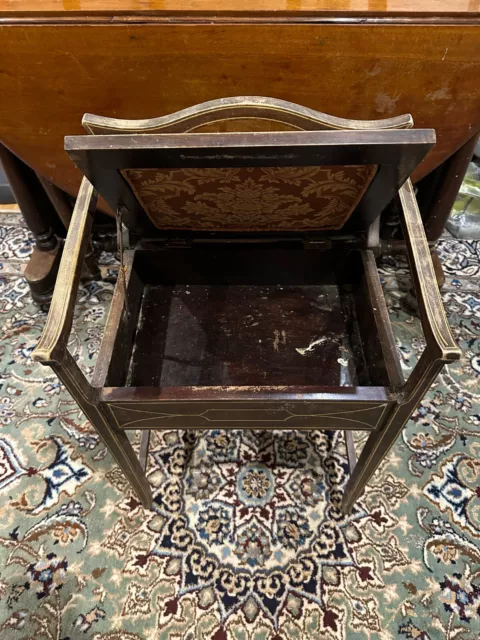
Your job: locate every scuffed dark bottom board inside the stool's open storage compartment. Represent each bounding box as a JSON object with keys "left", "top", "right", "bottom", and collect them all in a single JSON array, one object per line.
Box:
[{"left": 129, "top": 285, "right": 369, "bottom": 387}]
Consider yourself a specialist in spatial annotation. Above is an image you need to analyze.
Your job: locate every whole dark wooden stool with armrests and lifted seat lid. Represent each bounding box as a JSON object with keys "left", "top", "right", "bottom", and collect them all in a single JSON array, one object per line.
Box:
[{"left": 34, "top": 98, "right": 460, "bottom": 511}]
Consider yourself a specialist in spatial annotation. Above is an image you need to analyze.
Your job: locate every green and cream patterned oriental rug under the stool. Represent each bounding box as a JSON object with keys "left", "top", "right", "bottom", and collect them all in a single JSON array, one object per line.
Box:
[{"left": 0, "top": 215, "right": 480, "bottom": 640}]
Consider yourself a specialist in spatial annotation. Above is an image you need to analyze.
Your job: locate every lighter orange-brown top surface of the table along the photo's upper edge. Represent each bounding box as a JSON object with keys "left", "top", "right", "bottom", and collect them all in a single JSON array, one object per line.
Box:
[{"left": 0, "top": 0, "right": 480, "bottom": 18}]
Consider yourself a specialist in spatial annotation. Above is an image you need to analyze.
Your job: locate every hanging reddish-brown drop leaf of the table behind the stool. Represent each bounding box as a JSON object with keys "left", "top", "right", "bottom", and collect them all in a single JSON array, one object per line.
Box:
[{"left": 0, "top": 21, "right": 480, "bottom": 208}]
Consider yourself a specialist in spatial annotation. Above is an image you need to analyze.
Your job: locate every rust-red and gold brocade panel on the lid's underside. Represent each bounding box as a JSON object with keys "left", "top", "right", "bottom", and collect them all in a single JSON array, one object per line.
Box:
[{"left": 122, "top": 165, "right": 377, "bottom": 232}]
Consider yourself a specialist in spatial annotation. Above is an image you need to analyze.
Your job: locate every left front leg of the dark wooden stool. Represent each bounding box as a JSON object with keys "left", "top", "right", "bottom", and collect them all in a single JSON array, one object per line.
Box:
[{"left": 51, "top": 351, "right": 152, "bottom": 509}]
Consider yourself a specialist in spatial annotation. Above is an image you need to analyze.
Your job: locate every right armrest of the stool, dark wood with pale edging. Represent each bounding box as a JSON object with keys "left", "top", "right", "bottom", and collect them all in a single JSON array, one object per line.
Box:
[{"left": 399, "top": 180, "right": 462, "bottom": 399}]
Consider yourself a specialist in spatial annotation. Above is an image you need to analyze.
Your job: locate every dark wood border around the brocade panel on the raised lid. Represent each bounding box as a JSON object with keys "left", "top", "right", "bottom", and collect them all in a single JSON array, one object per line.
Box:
[{"left": 65, "top": 129, "right": 435, "bottom": 237}]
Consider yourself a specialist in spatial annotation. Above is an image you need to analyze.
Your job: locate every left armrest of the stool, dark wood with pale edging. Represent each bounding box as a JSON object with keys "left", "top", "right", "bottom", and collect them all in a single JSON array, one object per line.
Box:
[{"left": 32, "top": 178, "right": 97, "bottom": 364}]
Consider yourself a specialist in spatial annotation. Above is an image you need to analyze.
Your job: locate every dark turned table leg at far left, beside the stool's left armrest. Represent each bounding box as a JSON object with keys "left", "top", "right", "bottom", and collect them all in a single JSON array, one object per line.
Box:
[{"left": 0, "top": 143, "right": 62, "bottom": 304}]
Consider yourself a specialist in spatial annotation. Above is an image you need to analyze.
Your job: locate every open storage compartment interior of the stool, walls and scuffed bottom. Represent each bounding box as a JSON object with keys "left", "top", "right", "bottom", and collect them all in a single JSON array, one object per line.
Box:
[{"left": 98, "top": 242, "right": 394, "bottom": 387}]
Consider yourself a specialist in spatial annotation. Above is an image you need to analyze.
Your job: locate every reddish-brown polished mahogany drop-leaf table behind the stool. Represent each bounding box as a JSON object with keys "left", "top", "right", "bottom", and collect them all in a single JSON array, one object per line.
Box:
[{"left": 0, "top": 0, "right": 480, "bottom": 299}]
